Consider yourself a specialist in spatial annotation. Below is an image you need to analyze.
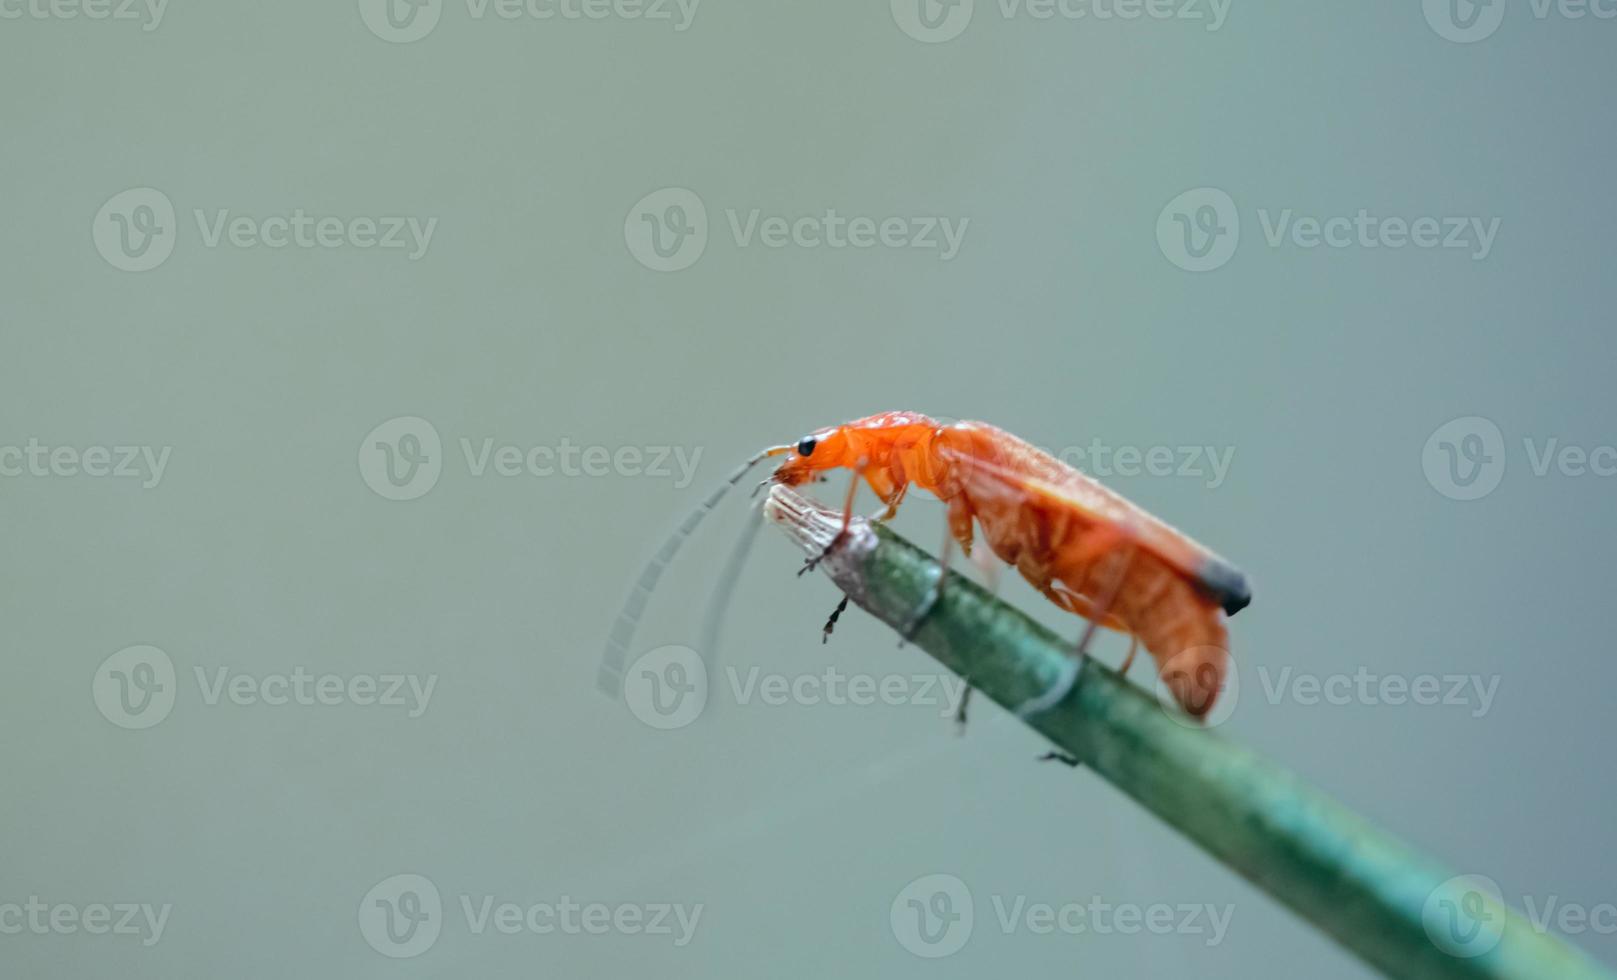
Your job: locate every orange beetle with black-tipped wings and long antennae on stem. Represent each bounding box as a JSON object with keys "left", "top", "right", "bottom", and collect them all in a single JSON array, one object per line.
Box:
[{"left": 603, "top": 412, "right": 1252, "bottom": 718}]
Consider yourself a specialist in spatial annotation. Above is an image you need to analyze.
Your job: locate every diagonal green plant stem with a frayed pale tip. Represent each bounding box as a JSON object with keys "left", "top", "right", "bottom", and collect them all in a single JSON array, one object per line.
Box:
[{"left": 765, "top": 487, "right": 1611, "bottom": 980}]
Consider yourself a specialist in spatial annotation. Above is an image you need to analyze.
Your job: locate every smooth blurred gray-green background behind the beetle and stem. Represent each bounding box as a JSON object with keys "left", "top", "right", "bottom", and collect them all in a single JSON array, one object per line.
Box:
[{"left": 0, "top": 0, "right": 1617, "bottom": 980}]
